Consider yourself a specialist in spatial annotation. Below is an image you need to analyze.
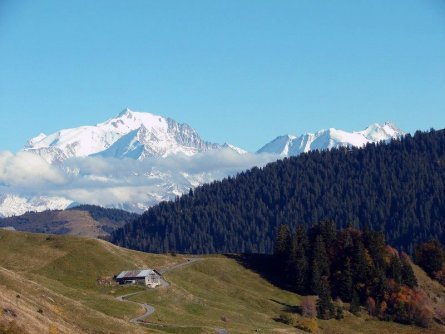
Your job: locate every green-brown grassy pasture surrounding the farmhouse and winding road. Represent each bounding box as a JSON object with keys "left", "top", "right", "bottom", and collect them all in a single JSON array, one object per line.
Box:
[{"left": 0, "top": 230, "right": 445, "bottom": 334}]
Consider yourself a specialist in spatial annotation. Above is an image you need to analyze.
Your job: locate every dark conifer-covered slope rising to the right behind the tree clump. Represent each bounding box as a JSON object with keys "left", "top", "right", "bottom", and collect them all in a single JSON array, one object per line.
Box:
[{"left": 111, "top": 130, "right": 445, "bottom": 253}]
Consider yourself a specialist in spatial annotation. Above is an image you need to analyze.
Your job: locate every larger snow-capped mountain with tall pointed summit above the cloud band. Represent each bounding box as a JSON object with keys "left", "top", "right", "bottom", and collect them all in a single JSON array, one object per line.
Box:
[{"left": 24, "top": 108, "right": 221, "bottom": 163}]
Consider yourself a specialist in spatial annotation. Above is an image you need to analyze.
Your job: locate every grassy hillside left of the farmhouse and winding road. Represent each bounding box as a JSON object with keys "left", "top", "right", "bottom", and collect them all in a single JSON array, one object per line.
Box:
[{"left": 0, "top": 231, "right": 183, "bottom": 333}]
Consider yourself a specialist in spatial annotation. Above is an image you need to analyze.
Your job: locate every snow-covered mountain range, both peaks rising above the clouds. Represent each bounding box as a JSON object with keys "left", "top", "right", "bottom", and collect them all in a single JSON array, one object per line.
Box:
[{"left": 24, "top": 109, "right": 405, "bottom": 163}]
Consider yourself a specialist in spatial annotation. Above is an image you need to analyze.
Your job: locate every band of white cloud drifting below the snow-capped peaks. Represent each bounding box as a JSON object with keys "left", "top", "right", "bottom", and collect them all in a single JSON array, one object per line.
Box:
[{"left": 0, "top": 149, "right": 278, "bottom": 213}]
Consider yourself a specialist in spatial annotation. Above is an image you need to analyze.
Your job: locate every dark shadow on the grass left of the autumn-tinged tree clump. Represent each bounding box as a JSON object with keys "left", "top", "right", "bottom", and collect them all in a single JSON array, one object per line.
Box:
[{"left": 224, "top": 254, "right": 292, "bottom": 291}]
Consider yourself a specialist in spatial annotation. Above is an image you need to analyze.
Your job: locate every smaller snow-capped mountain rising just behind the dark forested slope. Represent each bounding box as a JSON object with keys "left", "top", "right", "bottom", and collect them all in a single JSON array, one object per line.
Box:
[{"left": 258, "top": 123, "right": 405, "bottom": 157}]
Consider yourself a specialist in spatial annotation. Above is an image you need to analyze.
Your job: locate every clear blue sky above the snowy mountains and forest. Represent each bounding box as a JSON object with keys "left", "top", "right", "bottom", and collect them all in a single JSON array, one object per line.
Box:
[{"left": 0, "top": 0, "right": 445, "bottom": 151}]
